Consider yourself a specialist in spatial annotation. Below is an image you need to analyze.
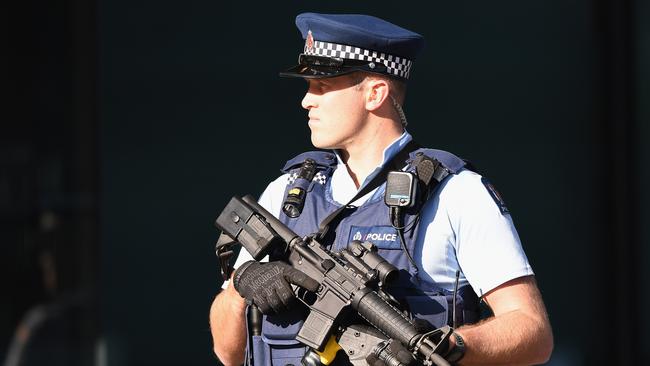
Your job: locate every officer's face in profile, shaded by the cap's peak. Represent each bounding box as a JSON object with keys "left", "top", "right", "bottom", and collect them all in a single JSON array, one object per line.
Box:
[{"left": 302, "top": 75, "right": 368, "bottom": 149}]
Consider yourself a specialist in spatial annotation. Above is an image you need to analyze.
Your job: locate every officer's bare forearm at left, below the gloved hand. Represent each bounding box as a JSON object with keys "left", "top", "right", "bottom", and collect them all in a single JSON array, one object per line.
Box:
[{"left": 210, "top": 282, "right": 246, "bottom": 365}]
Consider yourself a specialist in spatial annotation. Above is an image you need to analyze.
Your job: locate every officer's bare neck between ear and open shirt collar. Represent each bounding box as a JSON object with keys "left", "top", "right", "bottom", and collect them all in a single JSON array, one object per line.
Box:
[{"left": 339, "top": 119, "right": 404, "bottom": 189}]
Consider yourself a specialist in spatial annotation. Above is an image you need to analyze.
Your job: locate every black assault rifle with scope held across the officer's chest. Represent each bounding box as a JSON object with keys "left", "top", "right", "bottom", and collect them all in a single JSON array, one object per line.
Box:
[{"left": 216, "top": 196, "right": 451, "bottom": 366}]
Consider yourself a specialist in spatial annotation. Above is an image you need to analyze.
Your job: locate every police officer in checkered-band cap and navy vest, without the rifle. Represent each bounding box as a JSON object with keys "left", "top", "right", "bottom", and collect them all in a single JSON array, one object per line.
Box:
[{"left": 210, "top": 13, "right": 553, "bottom": 365}]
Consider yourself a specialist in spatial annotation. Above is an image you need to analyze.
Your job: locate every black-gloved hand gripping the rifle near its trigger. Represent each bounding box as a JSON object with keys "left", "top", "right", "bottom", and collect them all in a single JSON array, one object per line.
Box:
[{"left": 233, "top": 261, "right": 319, "bottom": 314}]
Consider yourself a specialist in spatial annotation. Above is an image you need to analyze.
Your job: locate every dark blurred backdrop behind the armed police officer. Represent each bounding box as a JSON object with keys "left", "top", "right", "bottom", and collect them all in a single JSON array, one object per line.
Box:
[{"left": 0, "top": 0, "right": 650, "bottom": 366}]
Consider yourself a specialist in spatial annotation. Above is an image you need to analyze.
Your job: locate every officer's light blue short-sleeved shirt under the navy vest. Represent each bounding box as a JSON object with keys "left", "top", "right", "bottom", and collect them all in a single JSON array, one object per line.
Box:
[{"left": 223, "top": 131, "right": 533, "bottom": 296}]
